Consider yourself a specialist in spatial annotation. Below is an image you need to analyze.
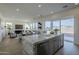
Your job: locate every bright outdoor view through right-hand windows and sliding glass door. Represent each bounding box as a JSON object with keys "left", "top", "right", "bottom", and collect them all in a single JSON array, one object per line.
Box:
[{"left": 45, "top": 17, "right": 74, "bottom": 42}]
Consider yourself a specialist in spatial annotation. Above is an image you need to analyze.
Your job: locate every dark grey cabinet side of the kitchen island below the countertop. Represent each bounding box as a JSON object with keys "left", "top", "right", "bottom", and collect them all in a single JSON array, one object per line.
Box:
[{"left": 36, "top": 36, "right": 64, "bottom": 55}]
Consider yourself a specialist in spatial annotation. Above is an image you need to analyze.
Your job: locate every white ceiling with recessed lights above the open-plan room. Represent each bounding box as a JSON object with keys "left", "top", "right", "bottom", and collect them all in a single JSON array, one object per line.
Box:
[{"left": 0, "top": 3, "right": 78, "bottom": 19}]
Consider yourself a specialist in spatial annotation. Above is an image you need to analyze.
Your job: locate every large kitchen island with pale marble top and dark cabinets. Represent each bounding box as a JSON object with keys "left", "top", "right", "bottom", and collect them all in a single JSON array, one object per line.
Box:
[{"left": 22, "top": 34, "right": 64, "bottom": 55}]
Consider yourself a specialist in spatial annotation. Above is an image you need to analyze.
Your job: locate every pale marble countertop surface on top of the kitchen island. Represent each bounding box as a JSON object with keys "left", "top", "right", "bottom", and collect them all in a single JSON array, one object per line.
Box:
[{"left": 22, "top": 34, "right": 60, "bottom": 44}]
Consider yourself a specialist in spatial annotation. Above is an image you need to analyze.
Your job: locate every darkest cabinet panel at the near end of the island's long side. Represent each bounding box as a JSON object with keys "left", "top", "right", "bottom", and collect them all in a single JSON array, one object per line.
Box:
[{"left": 37, "top": 41, "right": 49, "bottom": 55}]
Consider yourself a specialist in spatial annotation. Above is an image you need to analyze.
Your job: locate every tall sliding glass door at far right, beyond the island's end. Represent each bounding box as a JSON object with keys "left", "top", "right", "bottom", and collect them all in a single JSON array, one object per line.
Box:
[{"left": 61, "top": 17, "right": 74, "bottom": 41}]
